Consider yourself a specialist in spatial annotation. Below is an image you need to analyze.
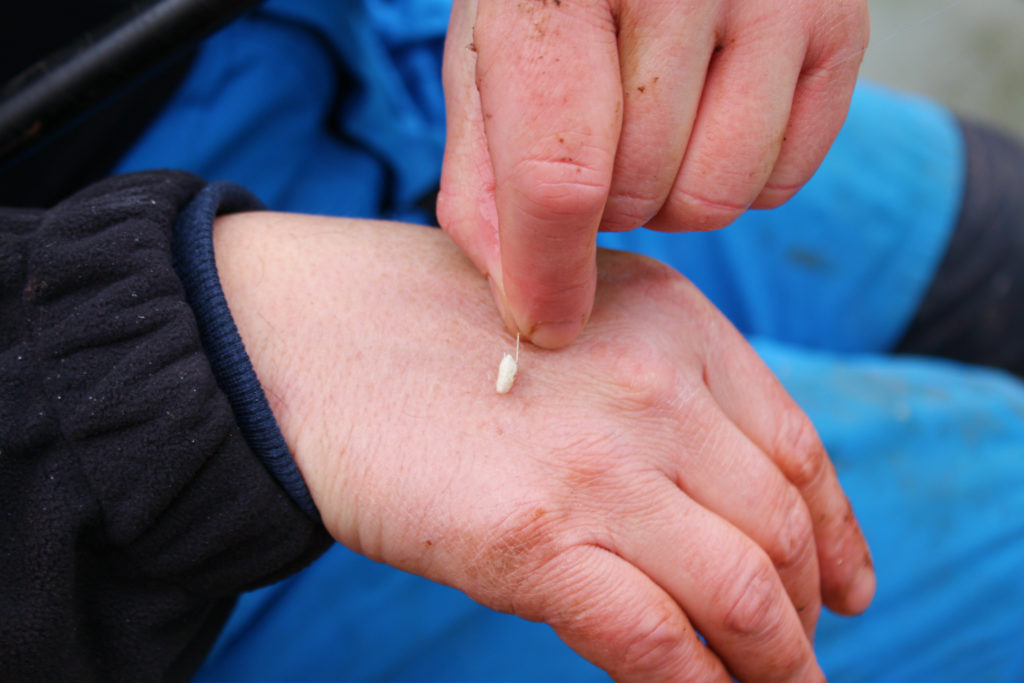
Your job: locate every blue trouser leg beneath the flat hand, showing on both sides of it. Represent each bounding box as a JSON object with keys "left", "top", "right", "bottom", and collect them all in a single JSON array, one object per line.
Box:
[{"left": 193, "top": 348, "right": 1024, "bottom": 681}]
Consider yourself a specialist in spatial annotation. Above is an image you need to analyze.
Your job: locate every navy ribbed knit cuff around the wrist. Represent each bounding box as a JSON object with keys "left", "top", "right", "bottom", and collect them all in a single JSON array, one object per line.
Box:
[{"left": 172, "top": 182, "right": 319, "bottom": 521}]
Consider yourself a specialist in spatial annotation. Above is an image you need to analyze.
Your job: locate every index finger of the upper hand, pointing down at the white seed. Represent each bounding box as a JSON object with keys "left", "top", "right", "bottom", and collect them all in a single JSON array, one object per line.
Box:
[{"left": 473, "top": 0, "right": 622, "bottom": 347}]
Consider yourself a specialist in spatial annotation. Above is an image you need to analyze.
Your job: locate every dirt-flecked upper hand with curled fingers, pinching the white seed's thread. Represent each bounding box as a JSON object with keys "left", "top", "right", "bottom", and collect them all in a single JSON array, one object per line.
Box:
[{"left": 438, "top": 0, "right": 868, "bottom": 347}]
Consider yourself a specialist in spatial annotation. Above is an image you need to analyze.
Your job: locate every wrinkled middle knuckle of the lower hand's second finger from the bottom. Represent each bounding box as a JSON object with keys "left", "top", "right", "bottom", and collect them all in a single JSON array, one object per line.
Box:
[{"left": 721, "top": 551, "right": 783, "bottom": 639}]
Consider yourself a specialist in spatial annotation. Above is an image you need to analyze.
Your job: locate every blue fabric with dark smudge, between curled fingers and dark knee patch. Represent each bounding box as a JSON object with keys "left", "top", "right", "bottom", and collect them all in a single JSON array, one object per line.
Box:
[{"left": 598, "top": 84, "right": 965, "bottom": 351}]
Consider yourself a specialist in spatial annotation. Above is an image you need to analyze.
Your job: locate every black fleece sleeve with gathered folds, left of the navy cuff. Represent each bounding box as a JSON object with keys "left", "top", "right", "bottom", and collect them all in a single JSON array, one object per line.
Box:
[{"left": 0, "top": 172, "right": 330, "bottom": 681}]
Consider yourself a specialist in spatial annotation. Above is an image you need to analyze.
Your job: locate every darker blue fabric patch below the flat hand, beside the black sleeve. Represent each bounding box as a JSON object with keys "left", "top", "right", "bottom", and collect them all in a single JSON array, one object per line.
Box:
[{"left": 197, "top": 546, "right": 607, "bottom": 681}]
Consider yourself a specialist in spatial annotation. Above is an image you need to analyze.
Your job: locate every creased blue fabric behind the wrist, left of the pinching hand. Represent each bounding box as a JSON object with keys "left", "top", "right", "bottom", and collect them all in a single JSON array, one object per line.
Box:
[{"left": 116, "top": 0, "right": 447, "bottom": 222}]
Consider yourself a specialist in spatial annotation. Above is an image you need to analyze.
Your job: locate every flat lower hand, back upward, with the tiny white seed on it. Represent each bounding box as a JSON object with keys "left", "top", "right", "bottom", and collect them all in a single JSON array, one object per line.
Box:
[{"left": 214, "top": 213, "right": 874, "bottom": 680}]
